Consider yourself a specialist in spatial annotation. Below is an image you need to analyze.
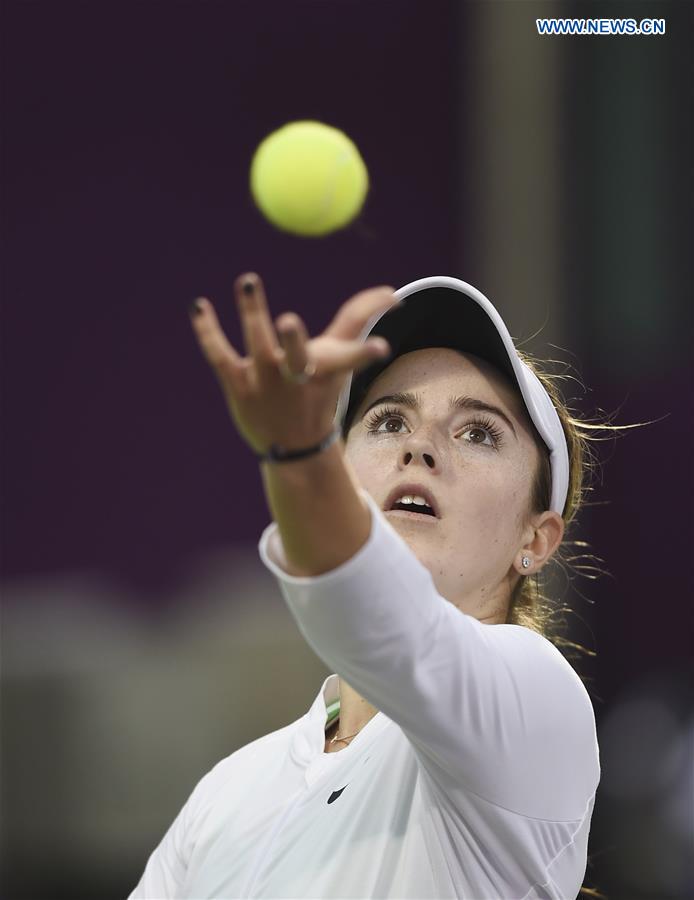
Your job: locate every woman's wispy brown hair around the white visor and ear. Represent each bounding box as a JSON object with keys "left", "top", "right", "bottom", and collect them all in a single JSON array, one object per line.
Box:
[{"left": 342, "top": 348, "right": 650, "bottom": 900}]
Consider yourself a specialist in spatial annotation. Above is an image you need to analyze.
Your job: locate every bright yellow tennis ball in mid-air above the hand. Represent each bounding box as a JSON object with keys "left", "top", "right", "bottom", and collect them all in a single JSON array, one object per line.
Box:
[{"left": 250, "top": 120, "right": 369, "bottom": 237}]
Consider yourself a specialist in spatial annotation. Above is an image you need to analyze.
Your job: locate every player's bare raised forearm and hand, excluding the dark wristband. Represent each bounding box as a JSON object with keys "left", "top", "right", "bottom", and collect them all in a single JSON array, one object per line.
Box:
[{"left": 193, "top": 273, "right": 397, "bottom": 575}]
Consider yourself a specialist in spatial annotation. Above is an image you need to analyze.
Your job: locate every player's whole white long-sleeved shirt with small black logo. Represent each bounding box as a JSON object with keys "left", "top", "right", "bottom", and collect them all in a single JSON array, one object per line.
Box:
[{"left": 130, "top": 488, "right": 600, "bottom": 900}]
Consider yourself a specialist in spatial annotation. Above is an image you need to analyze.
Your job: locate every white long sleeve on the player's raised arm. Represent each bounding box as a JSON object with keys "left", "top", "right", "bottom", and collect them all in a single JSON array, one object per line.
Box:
[{"left": 258, "top": 488, "right": 600, "bottom": 821}]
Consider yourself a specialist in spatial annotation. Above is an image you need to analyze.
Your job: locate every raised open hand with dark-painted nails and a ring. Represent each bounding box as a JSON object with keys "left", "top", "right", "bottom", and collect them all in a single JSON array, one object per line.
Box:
[{"left": 191, "top": 272, "right": 399, "bottom": 454}]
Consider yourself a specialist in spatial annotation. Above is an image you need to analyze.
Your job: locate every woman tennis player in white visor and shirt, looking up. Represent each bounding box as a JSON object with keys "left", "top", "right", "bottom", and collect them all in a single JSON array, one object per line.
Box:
[{"left": 130, "top": 273, "right": 600, "bottom": 900}]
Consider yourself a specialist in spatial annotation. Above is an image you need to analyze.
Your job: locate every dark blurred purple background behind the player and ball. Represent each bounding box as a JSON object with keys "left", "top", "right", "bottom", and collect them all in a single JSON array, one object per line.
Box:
[{"left": 0, "top": 0, "right": 694, "bottom": 900}]
